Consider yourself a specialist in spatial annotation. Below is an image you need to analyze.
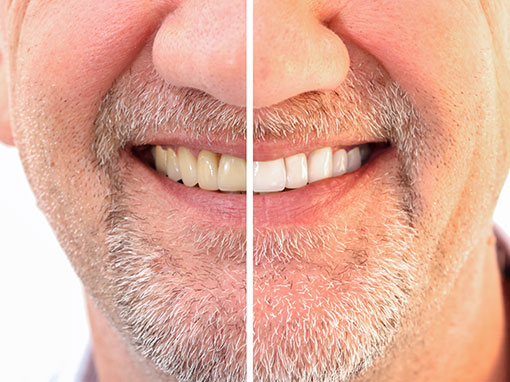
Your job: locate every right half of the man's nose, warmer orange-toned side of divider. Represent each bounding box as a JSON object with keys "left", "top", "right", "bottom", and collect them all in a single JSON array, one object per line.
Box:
[{"left": 253, "top": 0, "right": 349, "bottom": 108}]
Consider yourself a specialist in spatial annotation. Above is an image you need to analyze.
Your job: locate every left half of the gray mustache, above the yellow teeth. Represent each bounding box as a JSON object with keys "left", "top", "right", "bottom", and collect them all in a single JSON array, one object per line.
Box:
[{"left": 93, "top": 67, "right": 246, "bottom": 166}]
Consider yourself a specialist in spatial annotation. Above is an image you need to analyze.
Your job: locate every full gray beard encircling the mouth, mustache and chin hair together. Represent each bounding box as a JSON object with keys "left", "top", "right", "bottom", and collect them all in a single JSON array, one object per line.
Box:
[{"left": 94, "top": 57, "right": 425, "bottom": 382}]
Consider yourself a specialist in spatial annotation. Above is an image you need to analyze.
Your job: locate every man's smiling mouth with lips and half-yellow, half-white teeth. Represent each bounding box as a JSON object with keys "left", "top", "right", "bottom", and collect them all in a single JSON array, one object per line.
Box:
[{"left": 128, "top": 142, "right": 392, "bottom": 228}]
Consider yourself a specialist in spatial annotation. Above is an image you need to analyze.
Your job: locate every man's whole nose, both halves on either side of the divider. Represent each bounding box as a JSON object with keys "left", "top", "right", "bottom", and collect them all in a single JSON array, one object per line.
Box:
[{"left": 153, "top": 0, "right": 349, "bottom": 108}]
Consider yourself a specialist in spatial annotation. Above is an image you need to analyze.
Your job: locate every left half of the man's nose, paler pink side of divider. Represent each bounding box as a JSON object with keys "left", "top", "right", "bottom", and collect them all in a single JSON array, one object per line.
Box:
[{"left": 152, "top": 0, "right": 246, "bottom": 106}]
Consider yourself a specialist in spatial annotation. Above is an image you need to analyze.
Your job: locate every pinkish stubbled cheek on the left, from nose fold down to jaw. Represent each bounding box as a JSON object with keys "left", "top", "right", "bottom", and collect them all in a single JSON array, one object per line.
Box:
[{"left": 5, "top": 0, "right": 175, "bottom": 284}]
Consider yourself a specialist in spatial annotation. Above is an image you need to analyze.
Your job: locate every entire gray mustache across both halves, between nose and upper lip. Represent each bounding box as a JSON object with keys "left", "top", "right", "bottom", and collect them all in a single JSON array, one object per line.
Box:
[{"left": 93, "top": 63, "right": 423, "bottom": 173}]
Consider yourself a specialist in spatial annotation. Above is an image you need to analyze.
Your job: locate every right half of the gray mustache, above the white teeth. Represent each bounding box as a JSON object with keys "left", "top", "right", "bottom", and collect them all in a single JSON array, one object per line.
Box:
[{"left": 254, "top": 69, "right": 418, "bottom": 142}]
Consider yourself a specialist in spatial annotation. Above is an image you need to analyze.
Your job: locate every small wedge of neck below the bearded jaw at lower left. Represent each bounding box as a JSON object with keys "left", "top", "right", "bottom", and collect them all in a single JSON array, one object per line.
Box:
[{"left": 85, "top": 294, "right": 176, "bottom": 382}]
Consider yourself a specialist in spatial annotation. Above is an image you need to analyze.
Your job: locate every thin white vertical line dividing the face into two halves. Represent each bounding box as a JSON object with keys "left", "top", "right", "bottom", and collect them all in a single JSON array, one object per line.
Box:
[{"left": 246, "top": 0, "right": 254, "bottom": 382}]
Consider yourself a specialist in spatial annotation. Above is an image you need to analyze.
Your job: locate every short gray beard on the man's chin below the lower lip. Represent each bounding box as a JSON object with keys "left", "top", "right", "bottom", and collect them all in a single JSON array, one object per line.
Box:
[{"left": 100, "top": 165, "right": 424, "bottom": 382}]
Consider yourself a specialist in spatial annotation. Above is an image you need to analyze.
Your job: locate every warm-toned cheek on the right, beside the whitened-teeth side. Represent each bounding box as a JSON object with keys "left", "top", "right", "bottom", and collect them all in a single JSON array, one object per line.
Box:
[{"left": 331, "top": 0, "right": 501, "bottom": 252}]
